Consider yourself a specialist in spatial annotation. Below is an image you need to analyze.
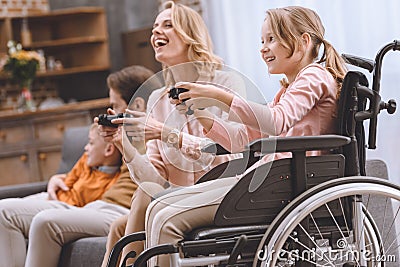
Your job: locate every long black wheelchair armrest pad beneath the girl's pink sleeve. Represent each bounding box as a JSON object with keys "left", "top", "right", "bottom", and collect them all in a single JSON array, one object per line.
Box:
[{"left": 248, "top": 135, "right": 350, "bottom": 154}]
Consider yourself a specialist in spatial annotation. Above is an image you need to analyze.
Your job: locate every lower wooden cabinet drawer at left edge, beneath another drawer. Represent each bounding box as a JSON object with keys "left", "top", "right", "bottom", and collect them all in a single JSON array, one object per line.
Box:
[{"left": 0, "top": 153, "right": 32, "bottom": 186}]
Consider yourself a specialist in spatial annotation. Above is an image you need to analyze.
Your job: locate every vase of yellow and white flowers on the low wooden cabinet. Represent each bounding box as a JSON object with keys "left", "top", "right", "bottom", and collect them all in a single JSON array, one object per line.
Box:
[{"left": 3, "top": 41, "right": 41, "bottom": 111}]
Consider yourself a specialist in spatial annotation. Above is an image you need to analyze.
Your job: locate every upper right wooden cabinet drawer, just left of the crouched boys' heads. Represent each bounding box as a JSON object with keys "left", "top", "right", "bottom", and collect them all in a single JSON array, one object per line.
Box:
[{"left": 34, "top": 113, "right": 92, "bottom": 143}]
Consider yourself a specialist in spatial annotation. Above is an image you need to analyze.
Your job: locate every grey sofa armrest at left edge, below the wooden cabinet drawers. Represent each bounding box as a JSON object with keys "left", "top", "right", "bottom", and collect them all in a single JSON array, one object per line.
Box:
[{"left": 0, "top": 181, "right": 47, "bottom": 199}]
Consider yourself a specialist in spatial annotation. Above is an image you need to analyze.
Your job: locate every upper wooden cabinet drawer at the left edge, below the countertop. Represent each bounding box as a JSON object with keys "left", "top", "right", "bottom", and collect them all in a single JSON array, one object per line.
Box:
[{"left": 0, "top": 122, "right": 32, "bottom": 147}]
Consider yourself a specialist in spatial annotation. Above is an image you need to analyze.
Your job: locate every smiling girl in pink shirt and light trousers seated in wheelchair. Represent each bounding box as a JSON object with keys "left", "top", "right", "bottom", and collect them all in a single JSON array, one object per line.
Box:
[{"left": 146, "top": 6, "right": 346, "bottom": 267}]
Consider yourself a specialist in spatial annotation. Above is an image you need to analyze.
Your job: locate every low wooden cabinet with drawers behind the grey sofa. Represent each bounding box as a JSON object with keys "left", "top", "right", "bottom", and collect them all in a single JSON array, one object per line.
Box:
[{"left": 0, "top": 98, "right": 109, "bottom": 185}]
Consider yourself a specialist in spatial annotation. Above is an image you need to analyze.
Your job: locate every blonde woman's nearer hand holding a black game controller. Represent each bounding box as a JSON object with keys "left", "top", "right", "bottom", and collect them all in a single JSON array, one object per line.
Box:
[{"left": 111, "top": 109, "right": 164, "bottom": 142}]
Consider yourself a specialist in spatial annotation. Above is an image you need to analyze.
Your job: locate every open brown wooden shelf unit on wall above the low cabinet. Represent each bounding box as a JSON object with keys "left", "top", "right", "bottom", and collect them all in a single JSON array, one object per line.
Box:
[{"left": 10, "top": 7, "right": 110, "bottom": 74}]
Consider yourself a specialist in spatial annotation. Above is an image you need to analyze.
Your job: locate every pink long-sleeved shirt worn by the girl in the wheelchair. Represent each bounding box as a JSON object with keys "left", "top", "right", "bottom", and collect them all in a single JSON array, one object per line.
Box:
[{"left": 206, "top": 64, "right": 338, "bottom": 166}]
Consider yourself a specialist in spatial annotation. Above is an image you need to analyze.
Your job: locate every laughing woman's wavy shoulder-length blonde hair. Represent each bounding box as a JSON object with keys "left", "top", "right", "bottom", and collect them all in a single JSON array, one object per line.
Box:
[{"left": 163, "top": 1, "right": 222, "bottom": 85}]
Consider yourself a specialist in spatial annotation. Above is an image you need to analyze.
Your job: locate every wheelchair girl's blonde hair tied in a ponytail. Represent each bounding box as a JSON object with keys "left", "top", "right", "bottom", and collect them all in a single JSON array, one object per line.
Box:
[{"left": 265, "top": 6, "right": 347, "bottom": 90}]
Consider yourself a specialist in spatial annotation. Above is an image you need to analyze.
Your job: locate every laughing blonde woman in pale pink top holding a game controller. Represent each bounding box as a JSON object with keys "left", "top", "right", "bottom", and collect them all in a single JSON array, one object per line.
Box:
[{"left": 99, "top": 1, "right": 245, "bottom": 266}]
